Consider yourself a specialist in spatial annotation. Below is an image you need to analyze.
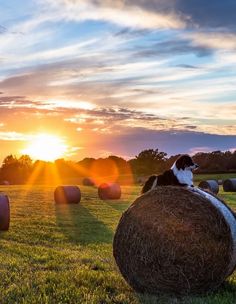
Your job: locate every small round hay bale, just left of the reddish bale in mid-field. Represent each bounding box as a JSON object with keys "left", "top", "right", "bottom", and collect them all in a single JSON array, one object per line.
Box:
[{"left": 54, "top": 186, "right": 81, "bottom": 204}]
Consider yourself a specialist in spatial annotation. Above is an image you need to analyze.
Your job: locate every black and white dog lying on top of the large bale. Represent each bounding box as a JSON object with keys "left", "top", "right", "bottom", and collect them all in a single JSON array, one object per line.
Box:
[{"left": 142, "top": 154, "right": 199, "bottom": 193}]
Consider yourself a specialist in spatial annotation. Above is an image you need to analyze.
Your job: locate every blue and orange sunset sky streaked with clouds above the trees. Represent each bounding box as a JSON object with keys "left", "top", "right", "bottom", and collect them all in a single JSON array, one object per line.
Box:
[{"left": 0, "top": 0, "right": 236, "bottom": 160}]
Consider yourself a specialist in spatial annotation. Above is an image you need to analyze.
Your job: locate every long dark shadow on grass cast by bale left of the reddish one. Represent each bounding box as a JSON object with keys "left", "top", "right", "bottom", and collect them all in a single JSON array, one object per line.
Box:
[{"left": 55, "top": 205, "right": 113, "bottom": 244}]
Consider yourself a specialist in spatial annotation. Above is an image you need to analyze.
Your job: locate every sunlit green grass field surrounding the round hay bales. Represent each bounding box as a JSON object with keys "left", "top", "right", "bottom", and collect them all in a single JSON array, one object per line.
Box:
[{"left": 0, "top": 176, "right": 236, "bottom": 304}]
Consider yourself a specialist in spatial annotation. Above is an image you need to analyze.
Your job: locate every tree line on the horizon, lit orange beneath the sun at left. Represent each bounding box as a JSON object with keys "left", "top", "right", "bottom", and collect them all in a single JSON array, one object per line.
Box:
[{"left": 0, "top": 149, "right": 236, "bottom": 184}]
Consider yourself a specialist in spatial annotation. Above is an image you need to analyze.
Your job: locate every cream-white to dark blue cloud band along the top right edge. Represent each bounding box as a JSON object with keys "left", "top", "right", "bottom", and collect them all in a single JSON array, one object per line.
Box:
[{"left": 45, "top": 0, "right": 236, "bottom": 32}]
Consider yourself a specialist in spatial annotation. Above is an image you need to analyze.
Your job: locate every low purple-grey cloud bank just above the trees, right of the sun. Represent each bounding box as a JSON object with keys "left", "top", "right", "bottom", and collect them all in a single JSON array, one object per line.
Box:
[{"left": 78, "top": 128, "right": 236, "bottom": 157}]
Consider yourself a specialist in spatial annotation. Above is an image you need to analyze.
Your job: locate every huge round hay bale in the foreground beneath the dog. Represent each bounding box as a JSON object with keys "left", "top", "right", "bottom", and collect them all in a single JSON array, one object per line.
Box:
[{"left": 113, "top": 186, "right": 236, "bottom": 295}]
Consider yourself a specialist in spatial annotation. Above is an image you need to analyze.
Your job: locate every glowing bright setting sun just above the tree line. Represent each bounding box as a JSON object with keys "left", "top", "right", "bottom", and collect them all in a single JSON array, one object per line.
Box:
[{"left": 21, "top": 134, "right": 67, "bottom": 161}]
